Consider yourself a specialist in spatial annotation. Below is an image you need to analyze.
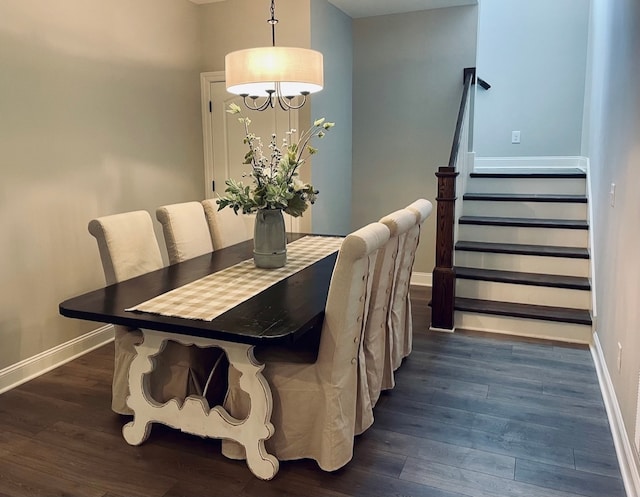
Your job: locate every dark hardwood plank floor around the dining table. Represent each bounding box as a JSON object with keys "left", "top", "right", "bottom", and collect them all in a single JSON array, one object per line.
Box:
[{"left": 0, "top": 289, "right": 625, "bottom": 497}]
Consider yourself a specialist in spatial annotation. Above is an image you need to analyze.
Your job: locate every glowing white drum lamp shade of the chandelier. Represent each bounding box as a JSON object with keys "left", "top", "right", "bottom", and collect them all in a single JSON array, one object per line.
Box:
[{"left": 224, "top": 47, "right": 324, "bottom": 97}]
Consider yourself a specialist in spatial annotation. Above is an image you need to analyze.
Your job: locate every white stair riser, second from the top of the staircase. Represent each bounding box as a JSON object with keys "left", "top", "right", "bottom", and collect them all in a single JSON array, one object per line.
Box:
[{"left": 462, "top": 200, "right": 587, "bottom": 220}]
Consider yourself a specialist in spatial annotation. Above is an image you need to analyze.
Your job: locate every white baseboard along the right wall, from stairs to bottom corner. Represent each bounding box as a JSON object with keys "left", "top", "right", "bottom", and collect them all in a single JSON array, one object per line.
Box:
[{"left": 591, "top": 332, "right": 640, "bottom": 497}]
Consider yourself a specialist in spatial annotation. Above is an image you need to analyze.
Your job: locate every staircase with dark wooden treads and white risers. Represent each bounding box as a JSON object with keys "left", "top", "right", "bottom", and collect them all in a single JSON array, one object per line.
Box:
[{"left": 454, "top": 168, "right": 592, "bottom": 343}]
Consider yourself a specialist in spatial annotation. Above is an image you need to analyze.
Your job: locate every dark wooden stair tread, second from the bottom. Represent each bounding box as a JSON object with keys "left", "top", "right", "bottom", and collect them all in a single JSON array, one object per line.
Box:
[{"left": 455, "top": 267, "right": 591, "bottom": 290}]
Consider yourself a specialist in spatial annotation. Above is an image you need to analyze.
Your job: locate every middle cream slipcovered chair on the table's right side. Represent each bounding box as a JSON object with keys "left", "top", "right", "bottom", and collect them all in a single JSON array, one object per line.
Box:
[{"left": 363, "top": 209, "right": 416, "bottom": 406}]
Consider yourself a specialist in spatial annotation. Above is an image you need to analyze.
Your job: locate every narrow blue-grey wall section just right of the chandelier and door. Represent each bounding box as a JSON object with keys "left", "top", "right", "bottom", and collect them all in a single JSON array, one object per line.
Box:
[{"left": 311, "top": 0, "right": 353, "bottom": 234}]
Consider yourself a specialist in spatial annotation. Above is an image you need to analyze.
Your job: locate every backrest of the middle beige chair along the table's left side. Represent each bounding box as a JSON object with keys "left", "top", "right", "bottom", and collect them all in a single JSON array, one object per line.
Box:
[{"left": 156, "top": 202, "right": 213, "bottom": 264}]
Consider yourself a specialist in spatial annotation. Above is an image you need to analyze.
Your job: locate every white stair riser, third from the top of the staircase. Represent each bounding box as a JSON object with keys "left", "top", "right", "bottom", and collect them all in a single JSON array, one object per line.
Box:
[{"left": 458, "top": 224, "right": 588, "bottom": 248}]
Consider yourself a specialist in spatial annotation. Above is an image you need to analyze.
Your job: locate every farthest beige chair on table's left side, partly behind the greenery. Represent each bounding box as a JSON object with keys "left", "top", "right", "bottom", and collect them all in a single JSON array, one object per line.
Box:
[{"left": 202, "top": 198, "right": 255, "bottom": 250}]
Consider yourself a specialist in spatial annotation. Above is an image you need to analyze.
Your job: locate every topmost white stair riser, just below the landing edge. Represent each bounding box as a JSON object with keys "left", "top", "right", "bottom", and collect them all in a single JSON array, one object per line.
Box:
[{"left": 466, "top": 177, "right": 587, "bottom": 195}]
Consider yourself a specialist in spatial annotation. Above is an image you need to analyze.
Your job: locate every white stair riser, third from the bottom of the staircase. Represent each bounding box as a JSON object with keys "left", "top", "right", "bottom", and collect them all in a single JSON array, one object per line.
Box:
[{"left": 454, "top": 250, "right": 589, "bottom": 277}]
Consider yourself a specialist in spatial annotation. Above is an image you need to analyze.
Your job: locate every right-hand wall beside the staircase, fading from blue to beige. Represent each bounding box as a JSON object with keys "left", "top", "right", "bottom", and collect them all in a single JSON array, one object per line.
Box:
[{"left": 582, "top": 0, "right": 640, "bottom": 484}]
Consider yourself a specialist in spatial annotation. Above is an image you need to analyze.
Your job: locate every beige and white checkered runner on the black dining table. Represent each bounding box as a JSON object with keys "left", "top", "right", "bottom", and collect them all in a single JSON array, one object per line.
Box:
[{"left": 126, "top": 236, "right": 343, "bottom": 321}]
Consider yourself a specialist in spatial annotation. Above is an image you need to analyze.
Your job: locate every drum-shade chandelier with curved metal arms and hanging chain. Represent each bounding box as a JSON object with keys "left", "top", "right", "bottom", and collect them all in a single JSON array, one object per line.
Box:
[{"left": 224, "top": 0, "right": 323, "bottom": 111}]
